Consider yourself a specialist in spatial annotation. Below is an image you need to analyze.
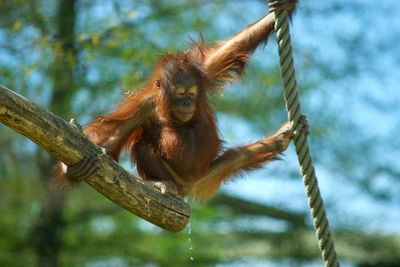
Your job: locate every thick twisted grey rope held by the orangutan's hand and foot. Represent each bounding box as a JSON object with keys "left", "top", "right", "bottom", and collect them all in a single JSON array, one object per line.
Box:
[{"left": 269, "top": 0, "right": 339, "bottom": 267}]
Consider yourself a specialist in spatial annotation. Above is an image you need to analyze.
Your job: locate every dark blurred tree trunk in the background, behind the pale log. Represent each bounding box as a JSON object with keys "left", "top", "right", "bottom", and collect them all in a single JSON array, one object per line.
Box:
[{"left": 34, "top": 0, "right": 77, "bottom": 267}]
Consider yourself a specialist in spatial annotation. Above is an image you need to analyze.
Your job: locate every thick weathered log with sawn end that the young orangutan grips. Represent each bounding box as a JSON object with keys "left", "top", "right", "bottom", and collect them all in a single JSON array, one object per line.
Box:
[{"left": 0, "top": 85, "right": 190, "bottom": 232}]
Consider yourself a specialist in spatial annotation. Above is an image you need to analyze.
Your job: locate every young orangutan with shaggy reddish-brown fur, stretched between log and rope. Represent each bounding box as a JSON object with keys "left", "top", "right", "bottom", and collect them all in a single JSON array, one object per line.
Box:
[{"left": 57, "top": 1, "right": 308, "bottom": 199}]
